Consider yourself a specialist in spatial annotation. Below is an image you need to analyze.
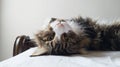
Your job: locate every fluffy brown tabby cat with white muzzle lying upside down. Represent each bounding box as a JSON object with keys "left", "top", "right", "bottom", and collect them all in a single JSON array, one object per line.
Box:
[{"left": 31, "top": 17, "right": 120, "bottom": 56}]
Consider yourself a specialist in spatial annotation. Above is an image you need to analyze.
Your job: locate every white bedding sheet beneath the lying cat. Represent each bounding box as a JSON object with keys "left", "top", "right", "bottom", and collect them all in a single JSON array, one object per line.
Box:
[{"left": 0, "top": 48, "right": 120, "bottom": 67}]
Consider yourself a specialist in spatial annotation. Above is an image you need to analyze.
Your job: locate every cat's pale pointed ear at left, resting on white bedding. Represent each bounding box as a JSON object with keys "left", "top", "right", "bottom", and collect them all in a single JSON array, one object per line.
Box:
[{"left": 30, "top": 47, "right": 48, "bottom": 57}]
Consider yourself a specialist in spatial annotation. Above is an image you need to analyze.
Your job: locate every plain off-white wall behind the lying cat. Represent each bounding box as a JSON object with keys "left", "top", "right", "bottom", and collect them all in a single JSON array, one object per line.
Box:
[{"left": 0, "top": 0, "right": 120, "bottom": 60}]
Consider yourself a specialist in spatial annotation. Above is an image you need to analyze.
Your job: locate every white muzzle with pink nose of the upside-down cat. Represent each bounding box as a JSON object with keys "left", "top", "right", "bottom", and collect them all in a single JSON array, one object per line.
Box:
[{"left": 49, "top": 18, "right": 72, "bottom": 39}]
